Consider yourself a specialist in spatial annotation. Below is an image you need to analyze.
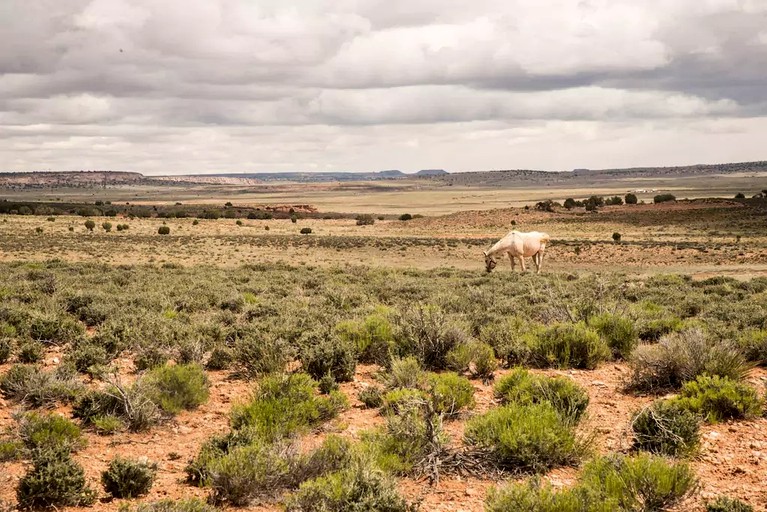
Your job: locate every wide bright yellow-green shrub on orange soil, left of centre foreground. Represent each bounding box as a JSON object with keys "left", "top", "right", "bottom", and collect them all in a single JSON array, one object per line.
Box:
[{"left": 230, "top": 373, "right": 347, "bottom": 440}]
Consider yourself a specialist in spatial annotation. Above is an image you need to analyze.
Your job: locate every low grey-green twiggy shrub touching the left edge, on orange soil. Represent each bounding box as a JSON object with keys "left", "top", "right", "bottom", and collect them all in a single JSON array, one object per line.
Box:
[{"left": 0, "top": 364, "right": 83, "bottom": 407}]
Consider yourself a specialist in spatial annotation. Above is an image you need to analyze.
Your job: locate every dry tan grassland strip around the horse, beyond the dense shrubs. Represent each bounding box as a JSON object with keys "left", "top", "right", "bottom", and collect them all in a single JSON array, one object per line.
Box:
[{"left": 0, "top": 200, "right": 767, "bottom": 276}]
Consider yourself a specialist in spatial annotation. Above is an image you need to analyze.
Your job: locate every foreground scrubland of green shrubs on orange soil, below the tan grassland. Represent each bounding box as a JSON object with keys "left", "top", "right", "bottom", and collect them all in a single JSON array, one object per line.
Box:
[{"left": 0, "top": 261, "right": 767, "bottom": 511}]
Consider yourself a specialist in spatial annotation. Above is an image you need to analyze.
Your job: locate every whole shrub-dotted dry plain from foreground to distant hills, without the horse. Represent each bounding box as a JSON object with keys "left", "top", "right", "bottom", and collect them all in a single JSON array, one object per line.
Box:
[{"left": 0, "top": 182, "right": 767, "bottom": 512}]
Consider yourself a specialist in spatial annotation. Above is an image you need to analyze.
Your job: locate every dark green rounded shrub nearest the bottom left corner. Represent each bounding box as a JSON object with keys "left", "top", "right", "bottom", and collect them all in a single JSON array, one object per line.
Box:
[{"left": 16, "top": 450, "right": 96, "bottom": 509}]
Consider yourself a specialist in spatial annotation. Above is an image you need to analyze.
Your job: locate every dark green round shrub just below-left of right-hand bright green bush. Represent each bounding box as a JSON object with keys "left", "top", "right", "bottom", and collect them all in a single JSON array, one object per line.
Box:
[{"left": 631, "top": 400, "right": 700, "bottom": 456}]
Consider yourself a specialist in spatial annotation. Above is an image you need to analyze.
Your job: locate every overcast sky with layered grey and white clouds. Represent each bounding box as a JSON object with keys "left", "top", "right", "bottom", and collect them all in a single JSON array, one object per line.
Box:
[{"left": 0, "top": 0, "right": 767, "bottom": 174}]
